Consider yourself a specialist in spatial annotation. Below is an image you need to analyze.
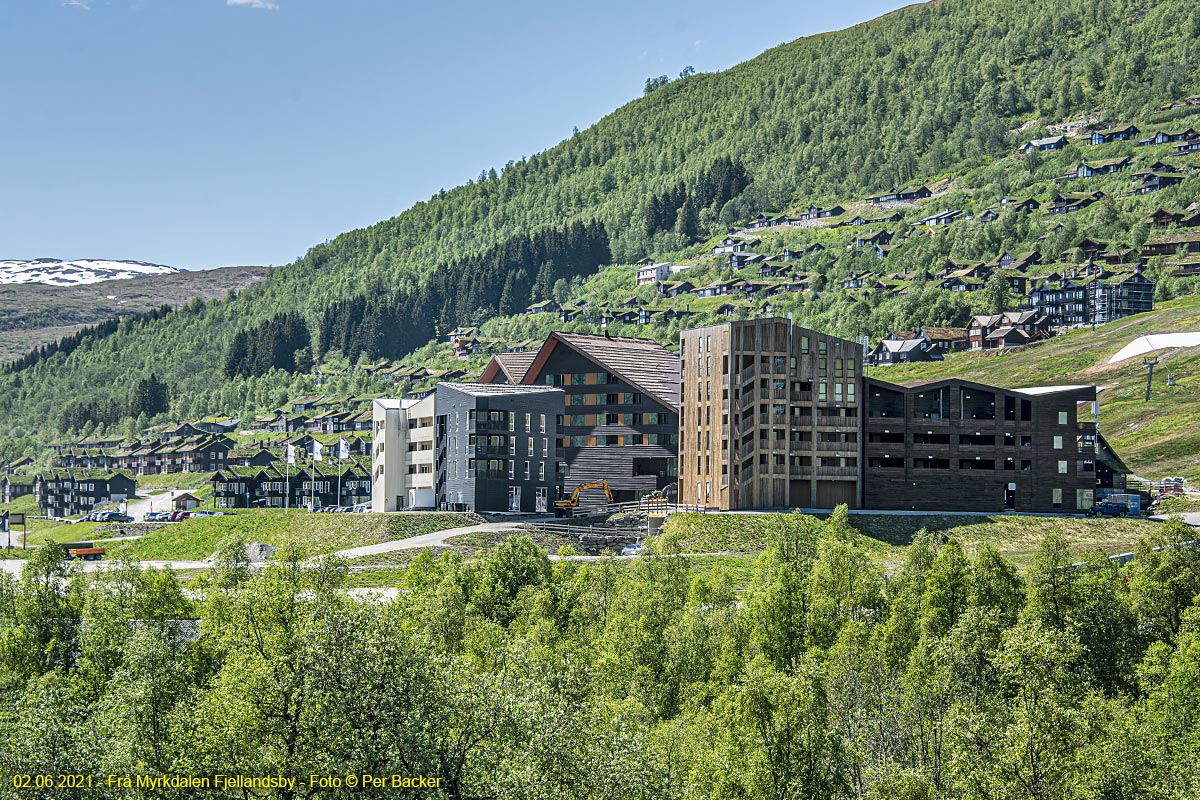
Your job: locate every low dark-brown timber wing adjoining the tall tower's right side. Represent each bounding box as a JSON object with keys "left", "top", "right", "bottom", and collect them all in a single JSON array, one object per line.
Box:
[{"left": 864, "top": 379, "right": 1104, "bottom": 513}]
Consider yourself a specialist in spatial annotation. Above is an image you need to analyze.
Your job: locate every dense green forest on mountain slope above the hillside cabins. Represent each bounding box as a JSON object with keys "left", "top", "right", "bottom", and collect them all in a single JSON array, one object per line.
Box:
[{"left": 0, "top": 0, "right": 1200, "bottom": 450}]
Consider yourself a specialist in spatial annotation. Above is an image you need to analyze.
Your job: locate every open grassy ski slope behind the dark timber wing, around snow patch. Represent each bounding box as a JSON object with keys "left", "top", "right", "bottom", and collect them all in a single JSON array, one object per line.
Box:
[{"left": 871, "top": 296, "right": 1200, "bottom": 480}]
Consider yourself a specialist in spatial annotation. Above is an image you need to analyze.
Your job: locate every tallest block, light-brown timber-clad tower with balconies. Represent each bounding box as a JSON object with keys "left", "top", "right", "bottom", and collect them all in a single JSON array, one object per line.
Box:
[{"left": 679, "top": 318, "right": 863, "bottom": 510}]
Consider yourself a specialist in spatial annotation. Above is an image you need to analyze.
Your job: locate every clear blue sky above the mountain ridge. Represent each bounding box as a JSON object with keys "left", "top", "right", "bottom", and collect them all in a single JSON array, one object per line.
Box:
[{"left": 0, "top": 0, "right": 905, "bottom": 269}]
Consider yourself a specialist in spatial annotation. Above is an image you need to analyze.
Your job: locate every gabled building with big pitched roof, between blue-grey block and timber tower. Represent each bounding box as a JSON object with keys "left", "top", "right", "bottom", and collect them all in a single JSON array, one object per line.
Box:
[{"left": 481, "top": 331, "right": 679, "bottom": 503}]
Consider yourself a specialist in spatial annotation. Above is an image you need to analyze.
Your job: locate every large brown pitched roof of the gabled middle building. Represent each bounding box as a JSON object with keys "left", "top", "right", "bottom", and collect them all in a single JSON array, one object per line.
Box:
[{"left": 522, "top": 331, "right": 679, "bottom": 408}]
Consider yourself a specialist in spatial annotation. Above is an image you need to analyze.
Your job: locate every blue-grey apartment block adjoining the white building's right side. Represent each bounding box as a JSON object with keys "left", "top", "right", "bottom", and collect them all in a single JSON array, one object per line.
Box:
[{"left": 433, "top": 383, "right": 564, "bottom": 513}]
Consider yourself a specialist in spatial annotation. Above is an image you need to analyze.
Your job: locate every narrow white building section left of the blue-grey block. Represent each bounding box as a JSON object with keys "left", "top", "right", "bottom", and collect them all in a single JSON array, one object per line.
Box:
[{"left": 371, "top": 392, "right": 437, "bottom": 512}]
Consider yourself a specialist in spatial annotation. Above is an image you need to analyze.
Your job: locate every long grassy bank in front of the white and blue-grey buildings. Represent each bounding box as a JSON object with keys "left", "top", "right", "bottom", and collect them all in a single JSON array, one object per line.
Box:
[{"left": 111, "top": 509, "right": 481, "bottom": 561}]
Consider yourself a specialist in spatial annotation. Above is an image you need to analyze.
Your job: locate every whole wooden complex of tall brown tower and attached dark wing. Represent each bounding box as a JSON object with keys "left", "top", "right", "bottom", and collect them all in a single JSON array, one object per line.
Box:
[{"left": 679, "top": 319, "right": 1128, "bottom": 513}]
